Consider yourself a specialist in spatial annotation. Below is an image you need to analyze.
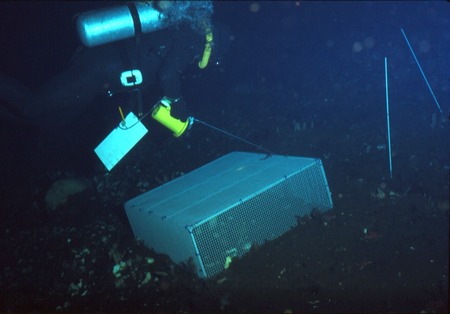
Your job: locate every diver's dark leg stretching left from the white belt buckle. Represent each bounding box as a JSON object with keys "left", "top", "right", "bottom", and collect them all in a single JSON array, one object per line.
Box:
[{"left": 0, "top": 46, "right": 123, "bottom": 129}]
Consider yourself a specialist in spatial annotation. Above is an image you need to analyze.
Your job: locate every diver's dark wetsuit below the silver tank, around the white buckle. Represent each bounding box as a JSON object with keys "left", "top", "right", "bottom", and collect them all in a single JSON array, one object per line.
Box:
[{"left": 0, "top": 23, "right": 204, "bottom": 129}]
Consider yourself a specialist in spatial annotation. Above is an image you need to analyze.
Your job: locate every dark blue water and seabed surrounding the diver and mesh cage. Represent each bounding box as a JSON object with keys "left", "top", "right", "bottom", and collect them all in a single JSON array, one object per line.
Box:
[{"left": 0, "top": 1, "right": 450, "bottom": 313}]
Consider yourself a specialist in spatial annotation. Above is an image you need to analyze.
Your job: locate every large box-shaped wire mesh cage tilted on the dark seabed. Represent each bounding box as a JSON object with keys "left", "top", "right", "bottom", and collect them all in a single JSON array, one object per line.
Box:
[{"left": 125, "top": 152, "right": 333, "bottom": 277}]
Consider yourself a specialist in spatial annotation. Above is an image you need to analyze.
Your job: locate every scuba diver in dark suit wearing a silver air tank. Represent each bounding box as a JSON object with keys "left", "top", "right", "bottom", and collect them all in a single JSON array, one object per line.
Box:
[{"left": 0, "top": 1, "right": 230, "bottom": 130}]
